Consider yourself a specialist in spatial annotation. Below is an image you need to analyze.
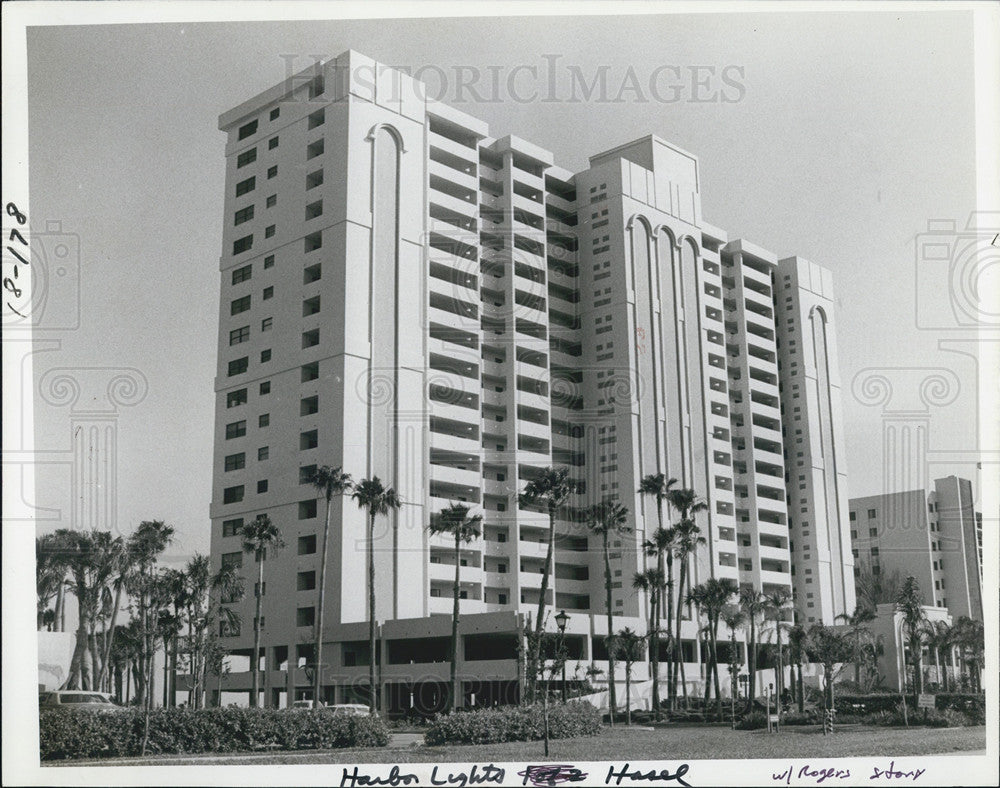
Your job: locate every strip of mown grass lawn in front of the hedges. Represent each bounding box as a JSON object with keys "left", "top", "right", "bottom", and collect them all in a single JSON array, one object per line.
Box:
[{"left": 44, "top": 726, "right": 986, "bottom": 766}]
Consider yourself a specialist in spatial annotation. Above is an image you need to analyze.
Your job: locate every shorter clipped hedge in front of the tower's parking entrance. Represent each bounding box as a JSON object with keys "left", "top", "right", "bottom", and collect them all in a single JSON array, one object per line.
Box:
[{"left": 424, "top": 701, "right": 601, "bottom": 745}]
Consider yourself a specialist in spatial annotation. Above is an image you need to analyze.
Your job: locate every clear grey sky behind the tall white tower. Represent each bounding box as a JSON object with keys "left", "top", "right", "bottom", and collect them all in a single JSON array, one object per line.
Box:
[{"left": 21, "top": 10, "right": 978, "bottom": 560}]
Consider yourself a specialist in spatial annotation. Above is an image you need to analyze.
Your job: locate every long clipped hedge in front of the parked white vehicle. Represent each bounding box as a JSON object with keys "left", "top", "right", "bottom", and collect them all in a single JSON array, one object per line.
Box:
[{"left": 39, "top": 707, "right": 389, "bottom": 761}]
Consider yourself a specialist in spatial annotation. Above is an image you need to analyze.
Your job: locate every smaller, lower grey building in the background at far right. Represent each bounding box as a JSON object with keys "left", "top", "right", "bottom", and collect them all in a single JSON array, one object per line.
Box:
[{"left": 850, "top": 476, "right": 983, "bottom": 621}]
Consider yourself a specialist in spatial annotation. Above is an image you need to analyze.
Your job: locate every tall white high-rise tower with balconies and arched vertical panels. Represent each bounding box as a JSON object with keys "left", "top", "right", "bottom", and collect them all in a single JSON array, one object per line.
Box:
[{"left": 211, "top": 52, "right": 854, "bottom": 712}]
